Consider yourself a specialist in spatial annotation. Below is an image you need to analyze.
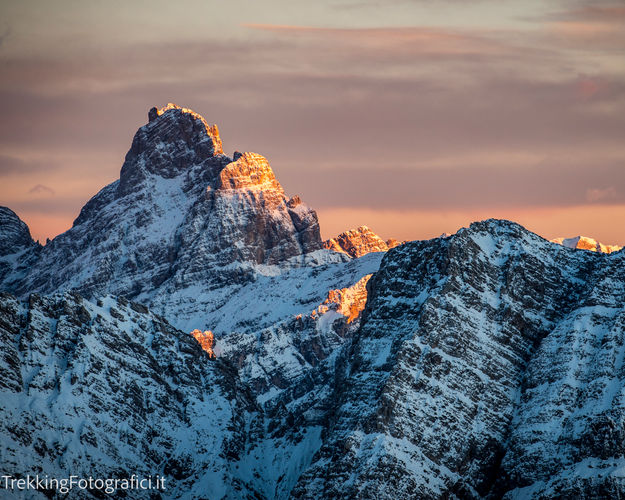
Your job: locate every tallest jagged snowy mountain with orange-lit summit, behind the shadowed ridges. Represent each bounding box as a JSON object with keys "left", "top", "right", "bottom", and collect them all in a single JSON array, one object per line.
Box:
[{"left": 3, "top": 104, "right": 356, "bottom": 333}]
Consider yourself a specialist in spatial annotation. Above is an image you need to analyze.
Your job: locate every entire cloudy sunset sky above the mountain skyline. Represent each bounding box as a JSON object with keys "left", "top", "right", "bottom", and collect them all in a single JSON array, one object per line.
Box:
[{"left": 0, "top": 0, "right": 625, "bottom": 245}]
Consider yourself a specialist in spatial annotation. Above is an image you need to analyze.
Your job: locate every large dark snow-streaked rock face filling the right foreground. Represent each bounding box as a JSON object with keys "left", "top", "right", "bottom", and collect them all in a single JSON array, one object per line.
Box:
[{"left": 293, "top": 221, "right": 625, "bottom": 498}]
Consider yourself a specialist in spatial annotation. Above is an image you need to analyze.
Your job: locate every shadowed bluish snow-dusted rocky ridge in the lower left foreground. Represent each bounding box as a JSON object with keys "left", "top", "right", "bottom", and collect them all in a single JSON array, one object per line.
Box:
[{"left": 0, "top": 294, "right": 256, "bottom": 499}]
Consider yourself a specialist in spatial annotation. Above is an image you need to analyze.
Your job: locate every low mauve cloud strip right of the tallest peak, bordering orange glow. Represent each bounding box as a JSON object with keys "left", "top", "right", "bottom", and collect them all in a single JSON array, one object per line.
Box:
[{"left": 279, "top": 157, "right": 625, "bottom": 212}]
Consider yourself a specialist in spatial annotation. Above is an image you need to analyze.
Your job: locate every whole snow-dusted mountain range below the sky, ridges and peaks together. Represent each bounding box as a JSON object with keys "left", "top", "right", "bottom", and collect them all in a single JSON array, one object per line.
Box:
[{"left": 0, "top": 105, "right": 625, "bottom": 499}]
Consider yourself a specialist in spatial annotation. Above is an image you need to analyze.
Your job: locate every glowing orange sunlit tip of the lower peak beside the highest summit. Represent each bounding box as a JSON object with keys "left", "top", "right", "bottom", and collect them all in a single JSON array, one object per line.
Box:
[{"left": 217, "top": 152, "right": 284, "bottom": 194}]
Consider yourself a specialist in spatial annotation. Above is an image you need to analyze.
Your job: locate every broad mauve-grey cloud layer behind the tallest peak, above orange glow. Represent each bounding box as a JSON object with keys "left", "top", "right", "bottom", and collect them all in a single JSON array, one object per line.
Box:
[{"left": 0, "top": 4, "right": 625, "bottom": 242}]
